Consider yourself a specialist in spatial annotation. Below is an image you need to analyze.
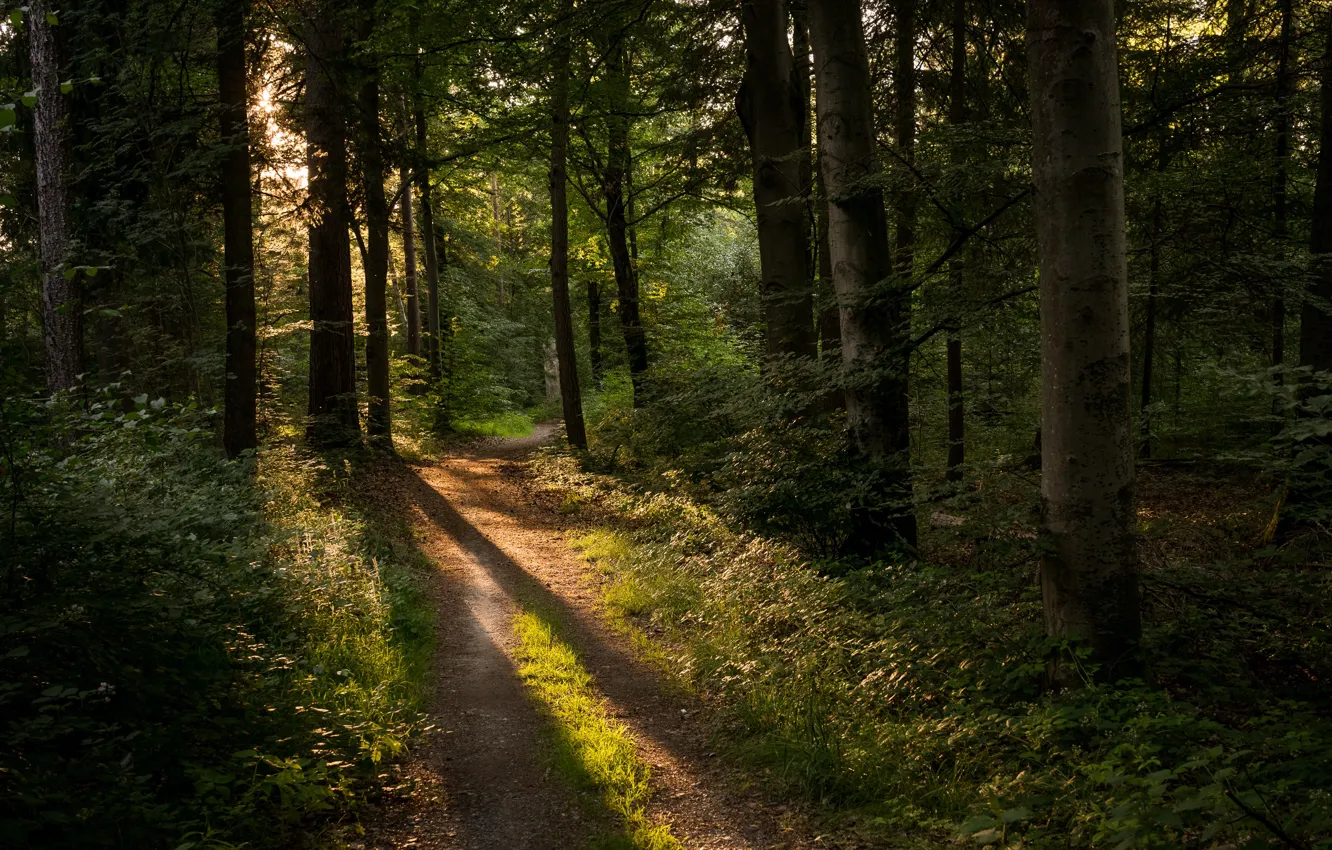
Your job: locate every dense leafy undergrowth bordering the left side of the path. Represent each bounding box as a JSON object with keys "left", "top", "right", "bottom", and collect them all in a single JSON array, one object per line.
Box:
[{"left": 0, "top": 397, "right": 432, "bottom": 850}]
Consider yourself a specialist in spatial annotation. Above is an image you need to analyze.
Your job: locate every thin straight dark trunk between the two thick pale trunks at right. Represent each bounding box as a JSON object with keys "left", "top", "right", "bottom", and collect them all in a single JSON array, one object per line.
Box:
[{"left": 947, "top": 0, "right": 967, "bottom": 482}]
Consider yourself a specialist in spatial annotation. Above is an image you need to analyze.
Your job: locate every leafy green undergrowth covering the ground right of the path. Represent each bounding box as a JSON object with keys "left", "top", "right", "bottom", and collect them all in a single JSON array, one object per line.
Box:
[{"left": 534, "top": 452, "right": 1332, "bottom": 847}]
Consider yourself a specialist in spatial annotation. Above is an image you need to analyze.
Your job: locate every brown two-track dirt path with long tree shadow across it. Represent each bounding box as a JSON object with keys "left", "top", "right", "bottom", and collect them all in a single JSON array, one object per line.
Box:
[{"left": 364, "top": 425, "right": 809, "bottom": 850}]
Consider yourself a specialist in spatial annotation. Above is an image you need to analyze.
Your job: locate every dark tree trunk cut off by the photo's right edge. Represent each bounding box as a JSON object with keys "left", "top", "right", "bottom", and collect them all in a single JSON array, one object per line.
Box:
[{"left": 1300, "top": 12, "right": 1332, "bottom": 372}]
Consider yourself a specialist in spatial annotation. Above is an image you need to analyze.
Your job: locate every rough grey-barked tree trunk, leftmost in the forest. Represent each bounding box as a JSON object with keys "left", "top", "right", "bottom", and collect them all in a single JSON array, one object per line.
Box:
[{"left": 24, "top": 0, "right": 83, "bottom": 393}]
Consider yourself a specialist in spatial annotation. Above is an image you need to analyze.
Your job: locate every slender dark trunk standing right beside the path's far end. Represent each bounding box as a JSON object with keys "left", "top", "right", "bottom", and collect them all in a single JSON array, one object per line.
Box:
[{"left": 550, "top": 0, "right": 587, "bottom": 449}]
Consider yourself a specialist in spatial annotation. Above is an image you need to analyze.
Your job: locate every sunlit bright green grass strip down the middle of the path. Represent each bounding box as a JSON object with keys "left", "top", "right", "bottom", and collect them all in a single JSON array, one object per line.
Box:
[{"left": 514, "top": 612, "right": 683, "bottom": 850}]
